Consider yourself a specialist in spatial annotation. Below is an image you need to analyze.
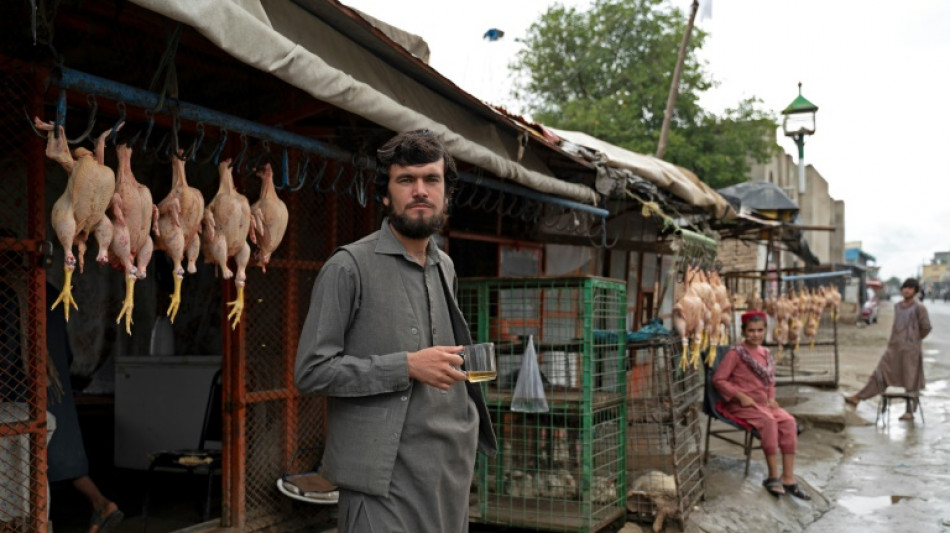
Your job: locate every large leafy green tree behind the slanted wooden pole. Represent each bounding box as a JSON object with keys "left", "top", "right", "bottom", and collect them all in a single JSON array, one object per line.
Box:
[{"left": 511, "top": 0, "right": 777, "bottom": 188}]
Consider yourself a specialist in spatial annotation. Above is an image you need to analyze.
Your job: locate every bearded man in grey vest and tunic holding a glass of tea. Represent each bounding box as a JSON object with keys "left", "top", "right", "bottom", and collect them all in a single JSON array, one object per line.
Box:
[{"left": 295, "top": 130, "right": 496, "bottom": 533}]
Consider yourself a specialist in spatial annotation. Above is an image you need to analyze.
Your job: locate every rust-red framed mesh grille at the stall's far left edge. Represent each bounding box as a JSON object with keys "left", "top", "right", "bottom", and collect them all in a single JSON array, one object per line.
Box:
[{"left": 0, "top": 61, "right": 49, "bottom": 532}]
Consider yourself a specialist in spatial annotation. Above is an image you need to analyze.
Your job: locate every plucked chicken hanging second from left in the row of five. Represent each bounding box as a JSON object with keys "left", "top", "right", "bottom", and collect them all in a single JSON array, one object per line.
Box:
[{"left": 109, "top": 144, "right": 158, "bottom": 335}]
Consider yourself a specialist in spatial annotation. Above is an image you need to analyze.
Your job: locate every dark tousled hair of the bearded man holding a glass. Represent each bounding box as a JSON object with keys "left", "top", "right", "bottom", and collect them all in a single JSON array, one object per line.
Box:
[{"left": 376, "top": 130, "right": 459, "bottom": 198}]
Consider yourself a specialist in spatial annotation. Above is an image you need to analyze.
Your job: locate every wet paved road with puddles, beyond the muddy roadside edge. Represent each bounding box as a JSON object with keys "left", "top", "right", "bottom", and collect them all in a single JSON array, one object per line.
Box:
[{"left": 805, "top": 300, "right": 950, "bottom": 533}]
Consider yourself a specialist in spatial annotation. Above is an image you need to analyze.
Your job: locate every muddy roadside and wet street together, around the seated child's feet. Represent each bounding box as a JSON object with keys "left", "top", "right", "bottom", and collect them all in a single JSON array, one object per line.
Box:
[{"left": 692, "top": 300, "right": 950, "bottom": 533}]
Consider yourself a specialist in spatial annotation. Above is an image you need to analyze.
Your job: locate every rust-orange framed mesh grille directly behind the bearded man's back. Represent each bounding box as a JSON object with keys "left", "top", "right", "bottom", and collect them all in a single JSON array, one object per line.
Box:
[{"left": 228, "top": 186, "right": 376, "bottom": 531}]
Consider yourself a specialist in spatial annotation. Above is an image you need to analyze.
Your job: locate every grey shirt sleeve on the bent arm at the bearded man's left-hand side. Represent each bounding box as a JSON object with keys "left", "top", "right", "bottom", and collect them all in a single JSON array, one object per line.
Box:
[{"left": 294, "top": 253, "right": 410, "bottom": 397}]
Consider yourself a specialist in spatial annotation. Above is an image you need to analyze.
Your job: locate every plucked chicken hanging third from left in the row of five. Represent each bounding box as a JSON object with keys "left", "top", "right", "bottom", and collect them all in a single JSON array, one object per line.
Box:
[{"left": 152, "top": 154, "right": 205, "bottom": 323}]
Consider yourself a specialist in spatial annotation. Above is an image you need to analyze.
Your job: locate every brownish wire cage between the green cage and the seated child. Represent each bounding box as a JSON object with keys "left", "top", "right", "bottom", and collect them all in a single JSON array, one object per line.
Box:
[{"left": 627, "top": 335, "right": 704, "bottom": 526}]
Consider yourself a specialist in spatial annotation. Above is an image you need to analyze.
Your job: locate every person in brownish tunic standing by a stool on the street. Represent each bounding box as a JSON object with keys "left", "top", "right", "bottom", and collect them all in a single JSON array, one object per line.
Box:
[{"left": 845, "top": 278, "right": 931, "bottom": 420}]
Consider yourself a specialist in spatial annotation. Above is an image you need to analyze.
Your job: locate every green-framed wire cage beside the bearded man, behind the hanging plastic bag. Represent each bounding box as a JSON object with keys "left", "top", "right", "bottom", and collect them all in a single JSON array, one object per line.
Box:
[{"left": 459, "top": 277, "right": 626, "bottom": 531}]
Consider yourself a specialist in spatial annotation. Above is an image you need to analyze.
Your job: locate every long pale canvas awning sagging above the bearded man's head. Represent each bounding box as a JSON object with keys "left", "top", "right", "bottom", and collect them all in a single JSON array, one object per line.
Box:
[{"left": 132, "top": 0, "right": 598, "bottom": 204}]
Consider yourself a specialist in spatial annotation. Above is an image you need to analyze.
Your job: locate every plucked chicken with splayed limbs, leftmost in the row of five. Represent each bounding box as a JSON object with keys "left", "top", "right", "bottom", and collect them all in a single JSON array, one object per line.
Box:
[{"left": 33, "top": 118, "right": 115, "bottom": 322}]
